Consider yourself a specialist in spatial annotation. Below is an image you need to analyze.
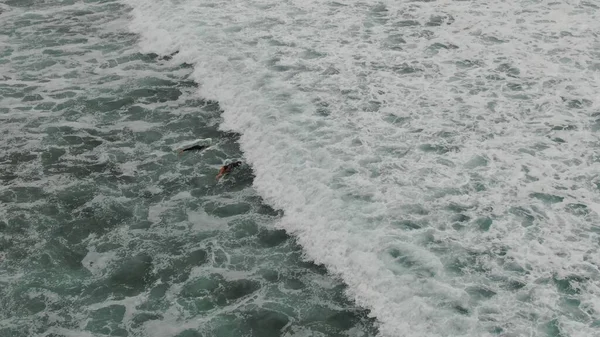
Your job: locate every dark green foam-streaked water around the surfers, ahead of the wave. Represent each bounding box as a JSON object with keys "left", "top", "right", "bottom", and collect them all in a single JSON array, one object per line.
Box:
[{"left": 0, "top": 1, "right": 376, "bottom": 337}]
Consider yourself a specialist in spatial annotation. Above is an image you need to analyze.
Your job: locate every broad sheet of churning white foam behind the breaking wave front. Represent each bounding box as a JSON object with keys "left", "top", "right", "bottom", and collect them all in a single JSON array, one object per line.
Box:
[{"left": 126, "top": 0, "right": 600, "bottom": 336}]
